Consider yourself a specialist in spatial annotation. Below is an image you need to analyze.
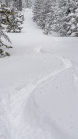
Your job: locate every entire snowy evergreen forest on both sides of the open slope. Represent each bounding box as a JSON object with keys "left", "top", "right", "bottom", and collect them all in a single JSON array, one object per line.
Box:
[{"left": 0, "top": 0, "right": 78, "bottom": 57}]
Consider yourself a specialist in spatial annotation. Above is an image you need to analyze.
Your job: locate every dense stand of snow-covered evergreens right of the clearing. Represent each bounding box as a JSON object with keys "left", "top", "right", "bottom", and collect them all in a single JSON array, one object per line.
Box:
[{"left": 33, "top": 0, "right": 78, "bottom": 36}]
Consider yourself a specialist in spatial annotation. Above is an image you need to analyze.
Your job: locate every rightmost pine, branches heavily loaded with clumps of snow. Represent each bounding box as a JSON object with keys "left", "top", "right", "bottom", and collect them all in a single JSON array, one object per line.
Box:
[{"left": 57, "top": 0, "right": 78, "bottom": 36}]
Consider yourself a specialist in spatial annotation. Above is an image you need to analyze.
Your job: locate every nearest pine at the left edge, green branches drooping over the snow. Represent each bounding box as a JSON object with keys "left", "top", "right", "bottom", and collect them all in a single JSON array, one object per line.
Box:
[{"left": 0, "top": 0, "right": 12, "bottom": 57}]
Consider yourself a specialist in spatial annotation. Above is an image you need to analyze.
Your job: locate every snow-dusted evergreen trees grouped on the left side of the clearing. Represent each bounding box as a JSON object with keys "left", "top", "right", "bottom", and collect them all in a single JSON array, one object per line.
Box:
[{"left": 0, "top": 0, "right": 24, "bottom": 57}]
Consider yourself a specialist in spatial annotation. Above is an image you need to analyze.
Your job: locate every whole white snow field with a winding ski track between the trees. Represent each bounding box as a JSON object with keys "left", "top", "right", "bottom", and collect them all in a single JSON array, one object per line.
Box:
[{"left": 0, "top": 9, "right": 78, "bottom": 139}]
